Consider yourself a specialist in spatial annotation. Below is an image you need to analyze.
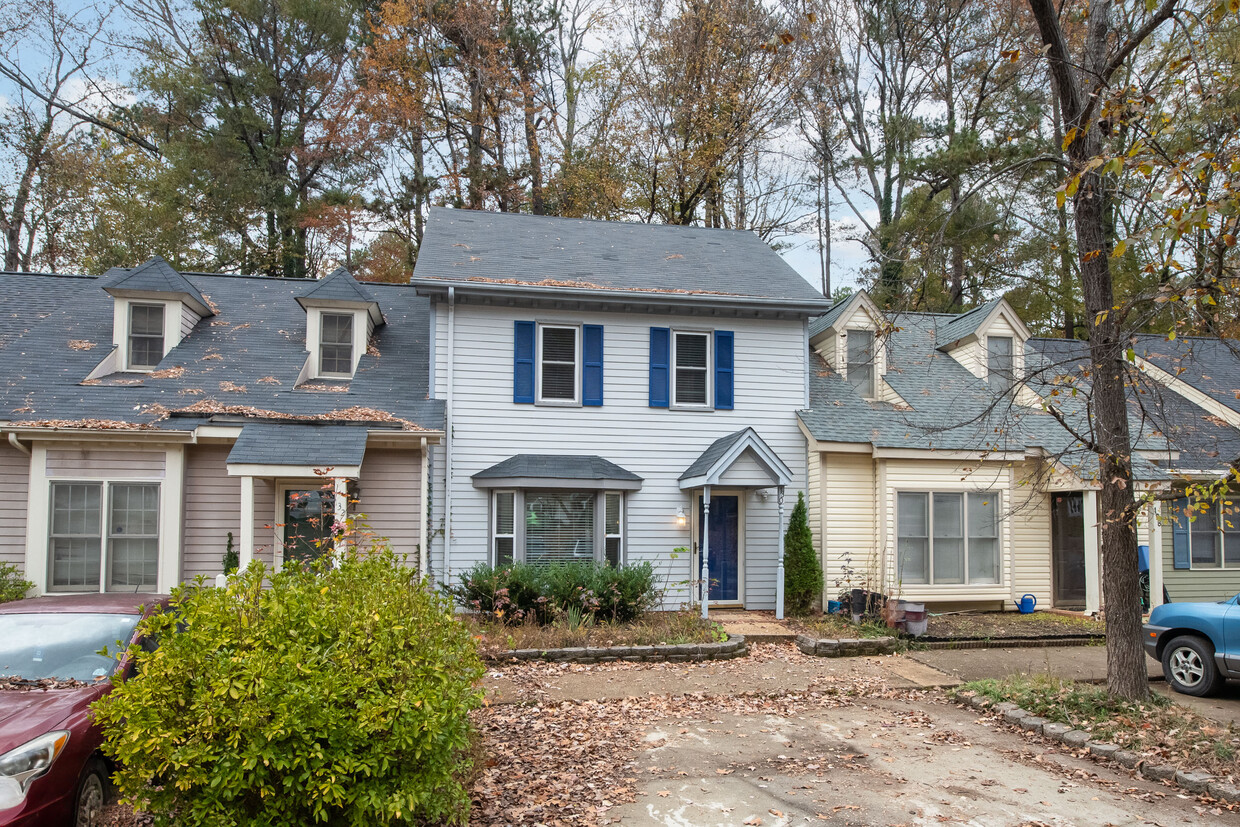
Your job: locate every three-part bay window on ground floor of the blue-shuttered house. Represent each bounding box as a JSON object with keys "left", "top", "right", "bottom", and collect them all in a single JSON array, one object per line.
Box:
[{"left": 491, "top": 489, "right": 624, "bottom": 565}]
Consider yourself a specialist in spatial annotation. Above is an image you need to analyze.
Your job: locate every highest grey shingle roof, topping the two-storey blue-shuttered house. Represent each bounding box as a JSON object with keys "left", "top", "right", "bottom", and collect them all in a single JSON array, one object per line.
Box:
[{"left": 414, "top": 208, "right": 827, "bottom": 309}]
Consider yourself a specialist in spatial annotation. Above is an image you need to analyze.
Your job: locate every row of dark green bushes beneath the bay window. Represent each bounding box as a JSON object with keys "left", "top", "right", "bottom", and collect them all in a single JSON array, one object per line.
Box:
[{"left": 448, "top": 562, "right": 661, "bottom": 624}]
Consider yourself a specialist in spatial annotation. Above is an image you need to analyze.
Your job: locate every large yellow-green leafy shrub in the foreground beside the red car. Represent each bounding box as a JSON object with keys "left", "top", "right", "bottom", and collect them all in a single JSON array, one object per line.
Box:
[{"left": 94, "top": 548, "right": 482, "bottom": 827}]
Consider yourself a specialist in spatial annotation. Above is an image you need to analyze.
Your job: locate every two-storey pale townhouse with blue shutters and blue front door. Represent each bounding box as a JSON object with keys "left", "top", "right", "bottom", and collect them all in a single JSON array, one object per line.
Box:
[{"left": 413, "top": 210, "right": 830, "bottom": 609}]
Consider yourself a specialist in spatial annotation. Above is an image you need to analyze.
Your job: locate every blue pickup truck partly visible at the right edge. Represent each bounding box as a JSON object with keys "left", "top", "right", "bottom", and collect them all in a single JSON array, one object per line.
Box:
[{"left": 1142, "top": 595, "right": 1240, "bottom": 696}]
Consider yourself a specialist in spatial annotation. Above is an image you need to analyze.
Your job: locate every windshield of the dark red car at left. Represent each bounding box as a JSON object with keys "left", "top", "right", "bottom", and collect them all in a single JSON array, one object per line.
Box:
[{"left": 0, "top": 613, "right": 140, "bottom": 682}]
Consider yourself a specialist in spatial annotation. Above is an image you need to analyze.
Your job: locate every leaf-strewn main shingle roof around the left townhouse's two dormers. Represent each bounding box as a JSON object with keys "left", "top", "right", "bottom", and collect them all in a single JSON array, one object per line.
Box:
[{"left": 0, "top": 273, "right": 444, "bottom": 430}]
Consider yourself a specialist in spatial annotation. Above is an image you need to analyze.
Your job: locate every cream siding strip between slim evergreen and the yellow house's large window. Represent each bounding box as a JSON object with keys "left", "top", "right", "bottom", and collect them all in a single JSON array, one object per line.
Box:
[{"left": 820, "top": 453, "right": 880, "bottom": 599}]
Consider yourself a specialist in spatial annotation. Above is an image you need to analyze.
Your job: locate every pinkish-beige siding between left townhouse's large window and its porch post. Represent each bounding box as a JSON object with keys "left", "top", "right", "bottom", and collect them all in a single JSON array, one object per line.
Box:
[{"left": 181, "top": 445, "right": 240, "bottom": 580}]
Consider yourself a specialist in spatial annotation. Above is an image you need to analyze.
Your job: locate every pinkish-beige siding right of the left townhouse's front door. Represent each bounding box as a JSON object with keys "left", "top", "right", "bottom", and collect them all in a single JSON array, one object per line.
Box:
[{"left": 355, "top": 448, "right": 422, "bottom": 567}]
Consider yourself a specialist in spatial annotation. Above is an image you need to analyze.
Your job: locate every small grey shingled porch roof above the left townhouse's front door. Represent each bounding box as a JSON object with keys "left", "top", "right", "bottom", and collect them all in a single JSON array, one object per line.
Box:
[{"left": 228, "top": 423, "right": 367, "bottom": 467}]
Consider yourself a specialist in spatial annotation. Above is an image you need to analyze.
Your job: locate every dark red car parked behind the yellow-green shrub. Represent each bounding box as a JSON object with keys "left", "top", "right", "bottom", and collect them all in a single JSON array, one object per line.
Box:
[{"left": 0, "top": 594, "right": 167, "bottom": 827}]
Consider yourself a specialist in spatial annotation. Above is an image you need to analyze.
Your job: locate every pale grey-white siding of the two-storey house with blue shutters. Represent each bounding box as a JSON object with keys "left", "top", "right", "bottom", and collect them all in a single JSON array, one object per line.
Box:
[{"left": 432, "top": 305, "right": 806, "bottom": 609}]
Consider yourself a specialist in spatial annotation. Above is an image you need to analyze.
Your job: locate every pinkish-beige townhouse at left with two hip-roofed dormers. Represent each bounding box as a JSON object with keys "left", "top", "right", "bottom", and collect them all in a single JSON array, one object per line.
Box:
[{"left": 0, "top": 259, "right": 443, "bottom": 593}]
